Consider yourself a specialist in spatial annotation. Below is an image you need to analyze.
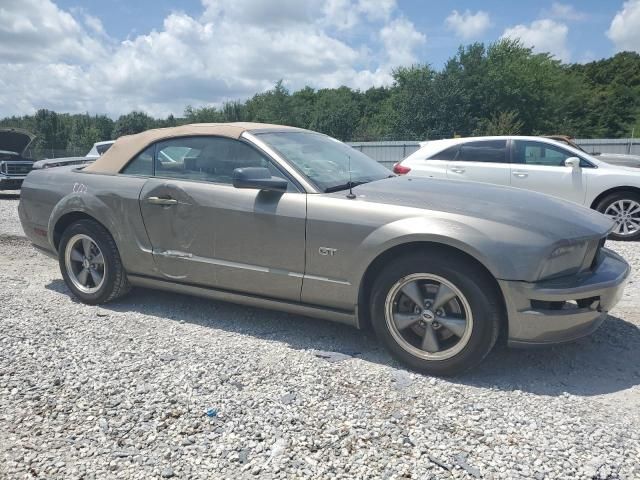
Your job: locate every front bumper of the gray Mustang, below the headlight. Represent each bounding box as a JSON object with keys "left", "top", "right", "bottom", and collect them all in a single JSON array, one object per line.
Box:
[{"left": 498, "top": 248, "right": 631, "bottom": 347}]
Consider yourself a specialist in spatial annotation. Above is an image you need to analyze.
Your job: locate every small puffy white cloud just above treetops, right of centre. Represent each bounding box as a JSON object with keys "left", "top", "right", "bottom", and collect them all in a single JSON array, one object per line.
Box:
[{"left": 502, "top": 18, "right": 571, "bottom": 62}]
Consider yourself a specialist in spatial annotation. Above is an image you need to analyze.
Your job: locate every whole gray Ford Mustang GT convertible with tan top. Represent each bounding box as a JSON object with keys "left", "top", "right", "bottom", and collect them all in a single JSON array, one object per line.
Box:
[{"left": 19, "top": 123, "right": 629, "bottom": 374}]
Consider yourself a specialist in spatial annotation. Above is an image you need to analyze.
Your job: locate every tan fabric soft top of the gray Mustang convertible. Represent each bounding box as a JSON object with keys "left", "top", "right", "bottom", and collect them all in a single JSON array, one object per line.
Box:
[{"left": 84, "top": 122, "right": 304, "bottom": 173}]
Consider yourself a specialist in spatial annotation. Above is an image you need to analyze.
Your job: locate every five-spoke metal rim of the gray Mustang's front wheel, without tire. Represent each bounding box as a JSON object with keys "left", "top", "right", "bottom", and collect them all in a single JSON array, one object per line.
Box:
[{"left": 385, "top": 273, "right": 473, "bottom": 360}]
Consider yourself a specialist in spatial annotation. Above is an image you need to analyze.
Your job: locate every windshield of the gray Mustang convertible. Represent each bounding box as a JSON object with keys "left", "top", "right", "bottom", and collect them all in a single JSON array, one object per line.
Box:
[{"left": 258, "top": 132, "right": 393, "bottom": 192}]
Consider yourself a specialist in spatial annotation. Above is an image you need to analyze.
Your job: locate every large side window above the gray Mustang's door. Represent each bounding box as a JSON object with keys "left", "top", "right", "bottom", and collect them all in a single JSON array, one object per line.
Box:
[{"left": 155, "top": 137, "right": 284, "bottom": 184}]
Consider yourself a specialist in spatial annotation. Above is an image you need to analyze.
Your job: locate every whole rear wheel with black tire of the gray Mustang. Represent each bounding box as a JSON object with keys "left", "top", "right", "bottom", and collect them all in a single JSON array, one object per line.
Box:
[{"left": 58, "top": 219, "right": 129, "bottom": 305}]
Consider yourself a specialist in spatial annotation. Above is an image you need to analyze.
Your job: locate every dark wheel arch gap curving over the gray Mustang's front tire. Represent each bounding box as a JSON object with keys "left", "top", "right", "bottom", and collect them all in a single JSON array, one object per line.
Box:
[{"left": 357, "top": 241, "right": 508, "bottom": 338}]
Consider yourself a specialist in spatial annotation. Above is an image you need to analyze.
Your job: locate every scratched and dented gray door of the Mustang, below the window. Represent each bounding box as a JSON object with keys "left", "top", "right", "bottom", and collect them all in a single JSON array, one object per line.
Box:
[{"left": 141, "top": 179, "right": 306, "bottom": 300}]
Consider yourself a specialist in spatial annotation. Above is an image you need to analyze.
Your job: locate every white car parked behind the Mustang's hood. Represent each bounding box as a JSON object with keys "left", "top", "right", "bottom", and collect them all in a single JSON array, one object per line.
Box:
[{"left": 393, "top": 136, "right": 640, "bottom": 240}]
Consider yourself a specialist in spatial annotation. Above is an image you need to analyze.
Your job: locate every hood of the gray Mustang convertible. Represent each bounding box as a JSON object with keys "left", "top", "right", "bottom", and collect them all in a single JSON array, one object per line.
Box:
[{"left": 342, "top": 176, "right": 613, "bottom": 242}]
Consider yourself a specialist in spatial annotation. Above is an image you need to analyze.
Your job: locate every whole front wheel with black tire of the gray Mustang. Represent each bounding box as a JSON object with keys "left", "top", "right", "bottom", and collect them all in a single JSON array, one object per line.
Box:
[{"left": 370, "top": 251, "right": 503, "bottom": 375}]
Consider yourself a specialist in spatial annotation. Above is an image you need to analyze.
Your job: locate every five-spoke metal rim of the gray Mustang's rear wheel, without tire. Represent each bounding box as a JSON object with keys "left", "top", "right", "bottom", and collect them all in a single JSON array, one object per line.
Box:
[{"left": 64, "top": 234, "right": 106, "bottom": 293}]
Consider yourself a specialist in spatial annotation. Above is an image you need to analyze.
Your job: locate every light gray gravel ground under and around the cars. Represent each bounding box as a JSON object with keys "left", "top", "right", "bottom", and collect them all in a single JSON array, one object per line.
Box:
[{"left": 0, "top": 195, "right": 640, "bottom": 479}]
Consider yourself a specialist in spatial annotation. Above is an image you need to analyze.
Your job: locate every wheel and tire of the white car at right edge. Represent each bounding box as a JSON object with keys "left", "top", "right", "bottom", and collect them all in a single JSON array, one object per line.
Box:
[{"left": 596, "top": 191, "right": 640, "bottom": 241}]
